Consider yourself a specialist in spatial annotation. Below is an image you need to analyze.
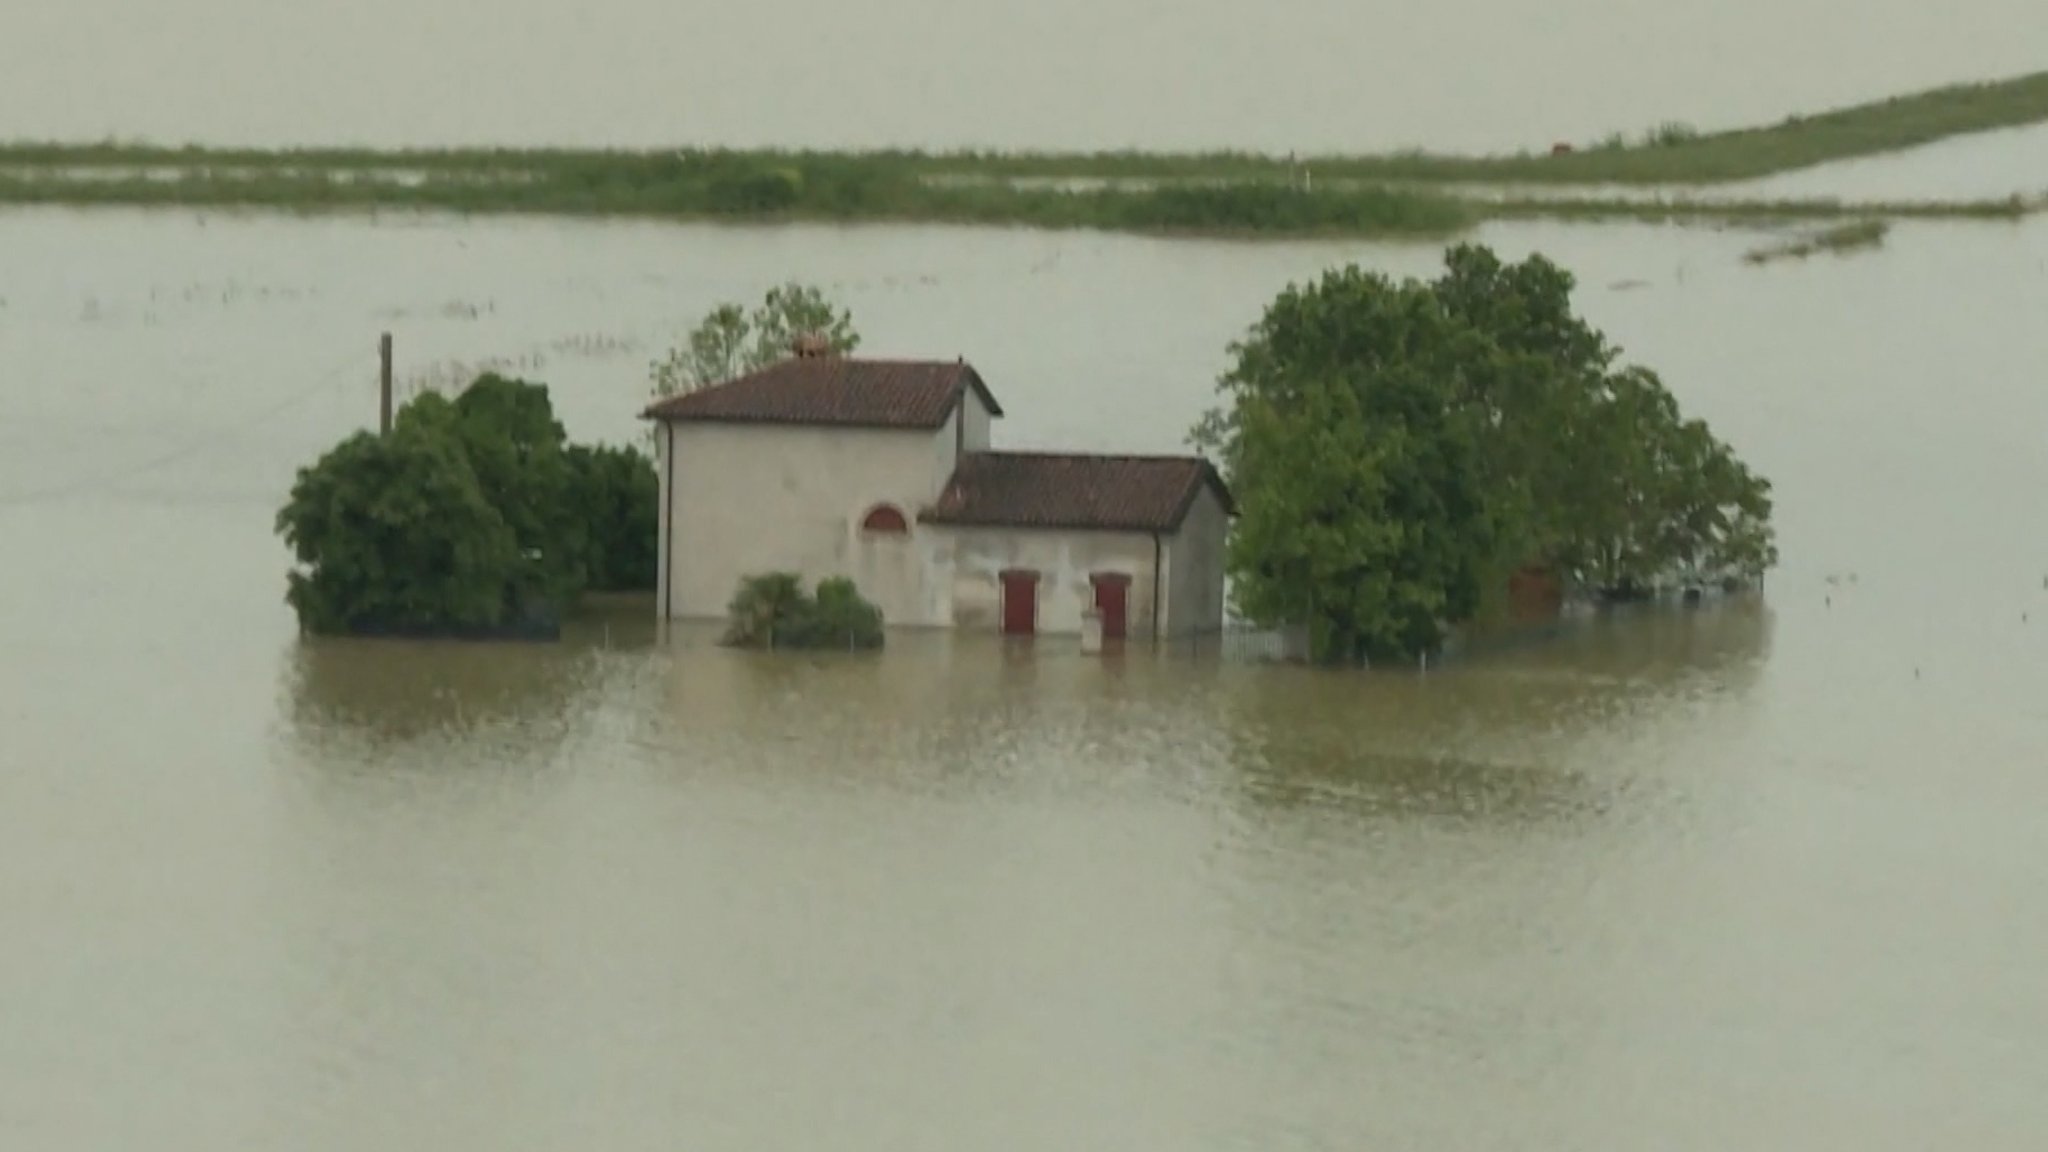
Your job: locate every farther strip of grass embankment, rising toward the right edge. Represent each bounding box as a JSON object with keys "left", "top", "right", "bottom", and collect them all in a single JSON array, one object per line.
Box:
[{"left": 0, "top": 72, "right": 2048, "bottom": 184}]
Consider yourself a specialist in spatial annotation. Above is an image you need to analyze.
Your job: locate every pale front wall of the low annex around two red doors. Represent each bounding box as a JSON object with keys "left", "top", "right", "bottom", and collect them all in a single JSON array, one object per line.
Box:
[{"left": 926, "top": 529, "right": 1153, "bottom": 637}]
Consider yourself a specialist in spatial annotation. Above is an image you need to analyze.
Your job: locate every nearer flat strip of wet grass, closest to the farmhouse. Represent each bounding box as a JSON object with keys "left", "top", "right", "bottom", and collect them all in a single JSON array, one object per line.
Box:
[{"left": 0, "top": 166, "right": 2048, "bottom": 238}]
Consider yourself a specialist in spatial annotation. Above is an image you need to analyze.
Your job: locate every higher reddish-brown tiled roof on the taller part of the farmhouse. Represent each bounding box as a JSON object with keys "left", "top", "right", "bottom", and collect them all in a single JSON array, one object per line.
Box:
[{"left": 641, "top": 357, "right": 1004, "bottom": 428}]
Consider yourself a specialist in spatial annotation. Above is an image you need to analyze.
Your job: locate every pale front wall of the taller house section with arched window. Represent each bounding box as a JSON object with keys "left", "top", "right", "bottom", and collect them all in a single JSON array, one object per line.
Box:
[{"left": 659, "top": 420, "right": 956, "bottom": 625}]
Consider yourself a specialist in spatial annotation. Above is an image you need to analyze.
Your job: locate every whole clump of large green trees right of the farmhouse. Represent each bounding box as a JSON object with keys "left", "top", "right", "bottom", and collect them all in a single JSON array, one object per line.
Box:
[{"left": 1194, "top": 246, "right": 1778, "bottom": 660}]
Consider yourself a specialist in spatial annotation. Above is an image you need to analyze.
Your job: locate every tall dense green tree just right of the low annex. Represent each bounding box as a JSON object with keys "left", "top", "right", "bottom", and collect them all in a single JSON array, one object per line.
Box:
[{"left": 1196, "top": 266, "right": 1493, "bottom": 660}]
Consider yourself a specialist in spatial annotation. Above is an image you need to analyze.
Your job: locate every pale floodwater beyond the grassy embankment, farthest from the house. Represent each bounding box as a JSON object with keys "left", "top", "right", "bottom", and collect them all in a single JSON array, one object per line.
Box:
[{"left": 0, "top": 0, "right": 2048, "bottom": 152}]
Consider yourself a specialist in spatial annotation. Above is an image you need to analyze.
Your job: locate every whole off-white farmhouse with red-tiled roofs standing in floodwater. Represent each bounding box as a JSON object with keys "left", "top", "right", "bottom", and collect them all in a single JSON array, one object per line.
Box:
[{"left": 645, "top": 344, "right": 1235, "bottom": 640}]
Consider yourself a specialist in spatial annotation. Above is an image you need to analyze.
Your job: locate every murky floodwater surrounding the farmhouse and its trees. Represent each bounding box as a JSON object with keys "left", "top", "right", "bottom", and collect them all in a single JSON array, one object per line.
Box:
[{"left": 0, "top": 201, "right": 2048, "bottom": 1152}]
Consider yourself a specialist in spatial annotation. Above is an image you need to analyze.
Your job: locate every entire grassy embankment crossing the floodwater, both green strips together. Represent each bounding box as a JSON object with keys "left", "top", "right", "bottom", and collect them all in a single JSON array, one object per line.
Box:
[{"left": 0, "top": 72, "right": 2048, "bottom": 236}]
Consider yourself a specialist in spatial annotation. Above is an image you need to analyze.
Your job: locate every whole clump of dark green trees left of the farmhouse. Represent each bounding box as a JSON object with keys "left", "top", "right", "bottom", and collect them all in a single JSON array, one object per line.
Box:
[{"left": 276, "top": 375, "right": 657, "bottom": 633}]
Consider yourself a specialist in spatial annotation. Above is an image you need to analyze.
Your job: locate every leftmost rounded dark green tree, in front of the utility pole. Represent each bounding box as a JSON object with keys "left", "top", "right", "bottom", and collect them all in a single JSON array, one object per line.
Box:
[{"left": 276, "top": 424, "right": 520, "bottom": 633}]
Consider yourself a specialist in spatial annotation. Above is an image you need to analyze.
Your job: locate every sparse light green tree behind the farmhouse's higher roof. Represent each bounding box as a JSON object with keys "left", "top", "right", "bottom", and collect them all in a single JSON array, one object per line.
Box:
[{"left": 649, "top": 281, "right": 860, "bottom": 400}]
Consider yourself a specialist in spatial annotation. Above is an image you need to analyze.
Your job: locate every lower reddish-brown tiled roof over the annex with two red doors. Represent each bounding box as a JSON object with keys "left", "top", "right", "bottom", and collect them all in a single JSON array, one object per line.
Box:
[{"left": 920, "top": 451, "right": 1237, "bottom": 533}]
